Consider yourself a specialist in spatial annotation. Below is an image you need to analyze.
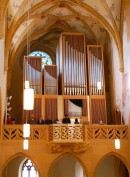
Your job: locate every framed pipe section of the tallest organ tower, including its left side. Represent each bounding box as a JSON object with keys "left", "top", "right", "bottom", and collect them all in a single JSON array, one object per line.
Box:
[{"left": 57, "top": 33, "right": 87, "bottom": 95}]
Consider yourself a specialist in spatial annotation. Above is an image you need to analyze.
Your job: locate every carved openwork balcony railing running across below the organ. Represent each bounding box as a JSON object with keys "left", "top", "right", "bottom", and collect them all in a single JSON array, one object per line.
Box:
[{"left": 1, "top": 124, "right": 128, "bottom": 142}]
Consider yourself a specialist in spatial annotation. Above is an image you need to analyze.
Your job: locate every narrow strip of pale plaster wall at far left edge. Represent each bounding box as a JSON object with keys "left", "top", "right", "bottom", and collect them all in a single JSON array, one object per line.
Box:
[{"left": 0, "top": 39, "right": 7, "bottom": 122}]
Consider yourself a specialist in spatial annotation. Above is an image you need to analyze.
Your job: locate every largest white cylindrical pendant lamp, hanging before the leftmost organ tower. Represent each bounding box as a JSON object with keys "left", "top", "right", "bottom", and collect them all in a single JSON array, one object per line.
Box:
[{"left": 24, "top": 88, "right": 34, "bottom": 110}]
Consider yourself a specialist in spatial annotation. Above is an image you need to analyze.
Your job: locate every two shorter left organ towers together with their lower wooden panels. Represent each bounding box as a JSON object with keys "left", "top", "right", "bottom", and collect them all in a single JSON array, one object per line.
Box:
[{"left": 23, "top": 56, "right": 58, "bottom": 123}]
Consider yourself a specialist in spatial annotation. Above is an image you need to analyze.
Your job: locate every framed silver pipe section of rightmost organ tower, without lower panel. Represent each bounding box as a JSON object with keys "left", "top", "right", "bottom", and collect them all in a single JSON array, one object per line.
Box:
[{"left": 88, "top": 46, "right": 104, "bottom": 95}]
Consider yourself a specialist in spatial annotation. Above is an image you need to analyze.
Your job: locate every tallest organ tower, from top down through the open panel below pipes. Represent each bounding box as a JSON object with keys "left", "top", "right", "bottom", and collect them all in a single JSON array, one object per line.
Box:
[{"left": 56, "top": 33, "right": 88, "bottom": 119}]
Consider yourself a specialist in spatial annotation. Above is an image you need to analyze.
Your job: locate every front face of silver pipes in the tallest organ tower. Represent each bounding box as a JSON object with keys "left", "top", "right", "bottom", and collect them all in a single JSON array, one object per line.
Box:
[{"left": 62, "top": 35, "right": 86, "bottom": 95}]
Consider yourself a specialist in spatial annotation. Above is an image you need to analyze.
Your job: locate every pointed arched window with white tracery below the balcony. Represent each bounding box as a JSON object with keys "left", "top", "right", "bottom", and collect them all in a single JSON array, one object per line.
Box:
[{"left": 21, "top": 159, "right": 39, "bottom": 177}]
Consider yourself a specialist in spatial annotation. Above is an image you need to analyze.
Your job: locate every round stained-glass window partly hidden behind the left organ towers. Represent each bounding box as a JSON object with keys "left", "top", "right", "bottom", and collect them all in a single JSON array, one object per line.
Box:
[{"left": 29, "top": 51, "right": 52, "bottom": 69}]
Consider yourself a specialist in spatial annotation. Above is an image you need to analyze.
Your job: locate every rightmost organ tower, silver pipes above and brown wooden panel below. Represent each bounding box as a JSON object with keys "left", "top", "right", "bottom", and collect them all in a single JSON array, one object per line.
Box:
[{"left": 87, "top": 45, "right": 107, "bottom": 124}]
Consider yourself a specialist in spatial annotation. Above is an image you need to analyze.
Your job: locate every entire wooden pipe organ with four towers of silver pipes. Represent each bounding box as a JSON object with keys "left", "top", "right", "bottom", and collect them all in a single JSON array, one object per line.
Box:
[{"left": 24, "top": 33, "right": 107, "bottom": 124}]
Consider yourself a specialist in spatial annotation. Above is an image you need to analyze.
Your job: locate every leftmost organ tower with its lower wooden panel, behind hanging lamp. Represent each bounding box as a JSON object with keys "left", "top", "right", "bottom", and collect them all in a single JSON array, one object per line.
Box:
[{"left": 23, "top": 56, "right": 42, "bottom": 123}]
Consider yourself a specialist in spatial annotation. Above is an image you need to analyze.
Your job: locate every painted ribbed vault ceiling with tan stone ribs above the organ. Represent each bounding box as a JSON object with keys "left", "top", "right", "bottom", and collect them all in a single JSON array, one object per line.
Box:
[{"left": 6, "top": 0, "right": 123, "bottom": 75}]
